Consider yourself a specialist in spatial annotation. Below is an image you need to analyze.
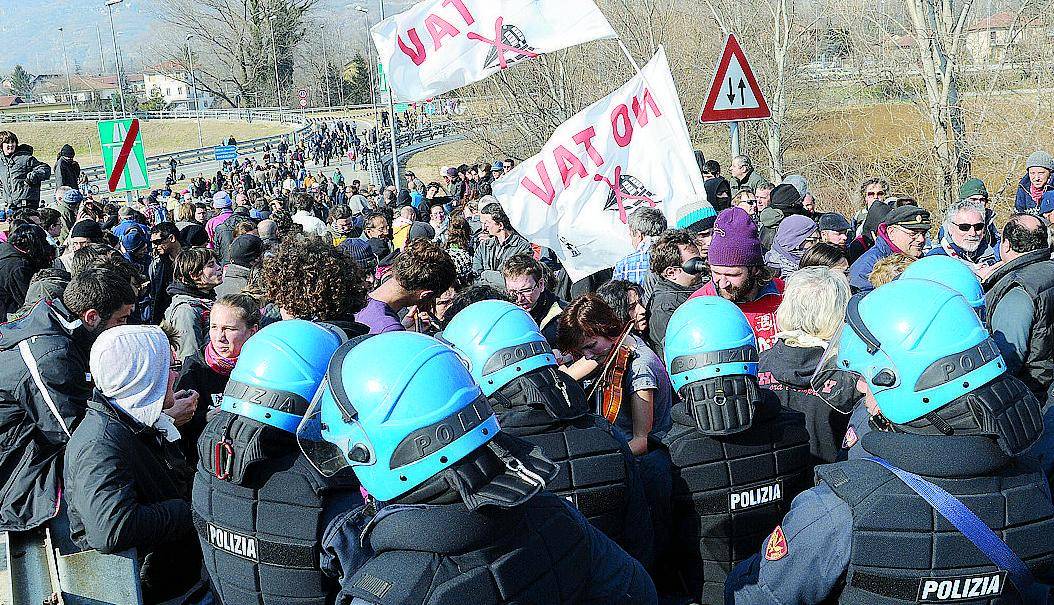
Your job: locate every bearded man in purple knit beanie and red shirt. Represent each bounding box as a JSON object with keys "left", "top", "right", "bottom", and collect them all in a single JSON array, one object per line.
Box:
[{"left": 691, "top": 208, "right": 783, "bottom": 351}]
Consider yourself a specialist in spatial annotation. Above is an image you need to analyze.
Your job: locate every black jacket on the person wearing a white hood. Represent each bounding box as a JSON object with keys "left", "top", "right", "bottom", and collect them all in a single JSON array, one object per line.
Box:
[{"left": 63, "top": 391, "right": 202, "bottom": 603}]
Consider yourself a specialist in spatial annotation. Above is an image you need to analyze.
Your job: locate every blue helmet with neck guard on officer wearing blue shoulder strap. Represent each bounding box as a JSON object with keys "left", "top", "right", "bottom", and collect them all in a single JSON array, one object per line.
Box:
[{"left": 813, "top": 277, "right": 1042, "bottom": 455}]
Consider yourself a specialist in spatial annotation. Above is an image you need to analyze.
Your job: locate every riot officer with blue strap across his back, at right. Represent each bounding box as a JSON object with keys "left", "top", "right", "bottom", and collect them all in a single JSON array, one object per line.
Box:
[{"left": 727, "top": 278, "right": 1054, "bottom": 604}]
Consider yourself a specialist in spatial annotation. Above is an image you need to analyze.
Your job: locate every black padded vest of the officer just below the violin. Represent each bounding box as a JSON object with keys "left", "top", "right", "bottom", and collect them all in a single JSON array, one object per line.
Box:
[{"left": 497, "top": 408, "right": 651, "bottom": 562}]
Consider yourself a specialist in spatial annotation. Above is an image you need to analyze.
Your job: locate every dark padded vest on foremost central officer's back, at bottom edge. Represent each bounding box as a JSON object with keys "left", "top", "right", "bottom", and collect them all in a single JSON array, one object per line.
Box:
[{"left": 343, "top": 492, "right": 607, "bottom": 605}]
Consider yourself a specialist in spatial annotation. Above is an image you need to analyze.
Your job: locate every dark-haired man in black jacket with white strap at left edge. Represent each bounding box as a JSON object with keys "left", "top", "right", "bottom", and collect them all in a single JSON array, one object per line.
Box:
[{"left": 0, "top": 269, "right": 136, "bottom": 531}]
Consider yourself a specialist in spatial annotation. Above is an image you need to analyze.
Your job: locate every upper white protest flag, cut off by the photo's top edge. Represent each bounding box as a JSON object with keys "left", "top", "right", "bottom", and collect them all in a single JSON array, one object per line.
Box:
[{"left": 370, "top": 0, "right": 617, "bottom": 102}]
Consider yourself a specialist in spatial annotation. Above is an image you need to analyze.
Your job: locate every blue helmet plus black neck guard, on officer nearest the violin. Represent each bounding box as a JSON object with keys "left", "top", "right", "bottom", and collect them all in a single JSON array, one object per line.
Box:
[{"left": 438, "top": 300, "right": 589, "bottom": 419}]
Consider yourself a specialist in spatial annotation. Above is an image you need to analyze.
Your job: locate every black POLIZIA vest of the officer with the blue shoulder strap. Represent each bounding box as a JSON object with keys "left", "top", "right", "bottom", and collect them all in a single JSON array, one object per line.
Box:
[{"left": 816, "top": 460, "right": 1054, "bottom": 605}]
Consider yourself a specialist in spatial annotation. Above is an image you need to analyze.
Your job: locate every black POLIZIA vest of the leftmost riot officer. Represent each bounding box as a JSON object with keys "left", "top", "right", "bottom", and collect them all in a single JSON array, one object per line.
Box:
[{"left": 192, "top": 412, "right": 357, "bottom": 605}]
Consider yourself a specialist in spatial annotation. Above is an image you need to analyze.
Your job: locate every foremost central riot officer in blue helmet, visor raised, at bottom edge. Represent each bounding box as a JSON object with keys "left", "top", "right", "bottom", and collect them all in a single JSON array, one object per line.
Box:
[{"left": 298, "top": 332, "right": 656, "bottom": 605}]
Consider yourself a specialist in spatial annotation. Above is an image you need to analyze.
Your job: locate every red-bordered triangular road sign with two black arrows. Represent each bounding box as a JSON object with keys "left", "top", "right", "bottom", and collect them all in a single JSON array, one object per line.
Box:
[{"left": 699, "top": 34, "right": 772, "bottom": 122}]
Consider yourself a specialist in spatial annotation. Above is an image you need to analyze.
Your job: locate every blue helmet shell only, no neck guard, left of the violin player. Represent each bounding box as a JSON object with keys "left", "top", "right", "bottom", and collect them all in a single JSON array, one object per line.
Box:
[{"left": 442, "top": 300, "right": 557, "bottom": 396}]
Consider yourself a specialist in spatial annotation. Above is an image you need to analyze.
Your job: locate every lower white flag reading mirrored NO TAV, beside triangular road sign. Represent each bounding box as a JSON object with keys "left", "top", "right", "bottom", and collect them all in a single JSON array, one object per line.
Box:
[{"left": 491, "top": 46, "right": 705, "bottom": 280}]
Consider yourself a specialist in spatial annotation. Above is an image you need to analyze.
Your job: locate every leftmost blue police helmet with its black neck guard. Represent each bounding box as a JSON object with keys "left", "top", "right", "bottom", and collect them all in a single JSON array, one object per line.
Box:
[{"left": 205, "top": 319, "right": 346, "bottom": 483}]
